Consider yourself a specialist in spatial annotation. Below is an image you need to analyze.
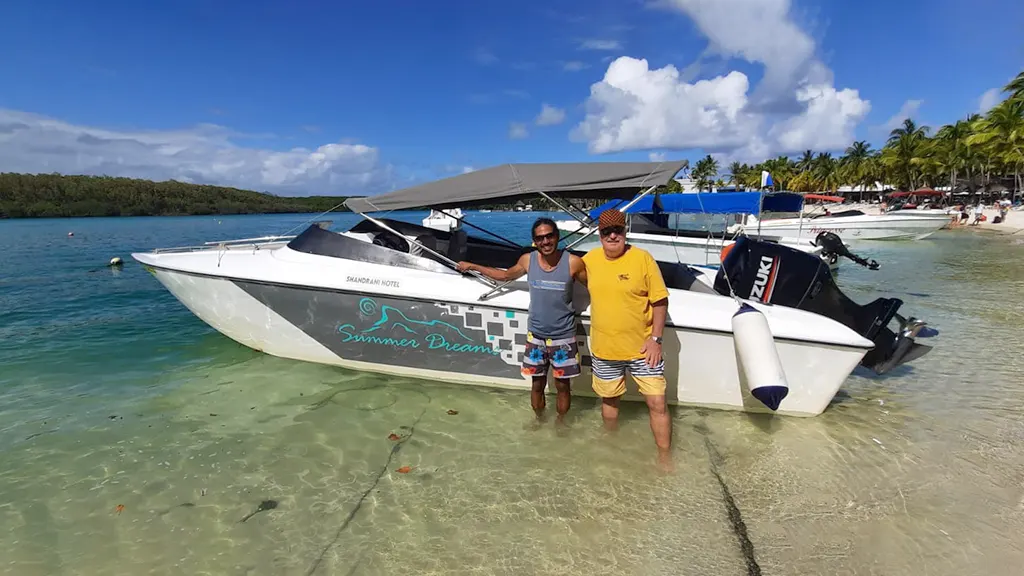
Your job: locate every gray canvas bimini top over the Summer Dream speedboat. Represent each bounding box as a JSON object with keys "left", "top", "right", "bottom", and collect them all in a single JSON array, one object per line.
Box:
[{"left": 345, "top": 160, "right": 687, "bottom": 212}]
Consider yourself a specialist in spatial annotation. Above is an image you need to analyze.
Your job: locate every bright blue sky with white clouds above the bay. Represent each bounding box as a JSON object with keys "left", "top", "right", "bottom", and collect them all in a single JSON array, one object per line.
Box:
[{"left": 0, "top": 0, "right": 1024, "bottom": 194}]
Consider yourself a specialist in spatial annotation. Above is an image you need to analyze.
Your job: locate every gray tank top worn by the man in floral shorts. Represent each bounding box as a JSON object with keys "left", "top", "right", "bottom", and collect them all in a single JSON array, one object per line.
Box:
[{"left": 526, "top": 252, "right": 575, "bottom": 338}]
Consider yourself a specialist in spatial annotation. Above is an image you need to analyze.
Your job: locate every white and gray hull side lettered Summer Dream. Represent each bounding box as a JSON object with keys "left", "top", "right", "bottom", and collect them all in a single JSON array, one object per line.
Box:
[{"left": 133, "top": 261, "right": 869, "bottom": 416}]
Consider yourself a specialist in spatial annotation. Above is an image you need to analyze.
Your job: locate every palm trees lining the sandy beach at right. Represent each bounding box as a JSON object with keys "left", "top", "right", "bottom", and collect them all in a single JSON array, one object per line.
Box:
[{"left": 690, "top": 72, "right": 1024, "bottom": 194}]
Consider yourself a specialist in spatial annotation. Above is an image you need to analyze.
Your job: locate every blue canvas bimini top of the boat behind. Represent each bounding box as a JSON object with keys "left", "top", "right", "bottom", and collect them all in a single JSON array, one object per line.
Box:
[{"left": 590, "top": 192, "right": 804, "bottom": 220}]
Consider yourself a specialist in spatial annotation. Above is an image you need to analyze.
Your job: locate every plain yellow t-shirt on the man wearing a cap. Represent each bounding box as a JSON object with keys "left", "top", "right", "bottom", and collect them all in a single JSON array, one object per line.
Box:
[{"left": 583, "top": 246, "right": 669, "bottom": 360}]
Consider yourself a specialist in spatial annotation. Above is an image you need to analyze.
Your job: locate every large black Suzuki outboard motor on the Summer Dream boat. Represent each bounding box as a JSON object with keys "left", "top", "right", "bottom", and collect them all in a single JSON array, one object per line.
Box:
[{"left": 715, "top": 236, "right": 937, "bottom": 374}]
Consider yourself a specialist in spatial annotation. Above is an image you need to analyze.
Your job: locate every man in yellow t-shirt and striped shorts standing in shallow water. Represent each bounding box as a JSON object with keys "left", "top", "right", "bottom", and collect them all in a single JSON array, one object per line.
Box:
[{"left": 583, "top": 209, "right": 672, "bottom": 455}]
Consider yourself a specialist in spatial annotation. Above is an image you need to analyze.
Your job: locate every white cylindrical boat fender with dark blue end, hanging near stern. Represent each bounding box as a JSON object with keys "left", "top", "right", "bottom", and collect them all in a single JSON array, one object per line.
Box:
[{"left": 732, "top": 302, "right": 790, "bottom": 411}]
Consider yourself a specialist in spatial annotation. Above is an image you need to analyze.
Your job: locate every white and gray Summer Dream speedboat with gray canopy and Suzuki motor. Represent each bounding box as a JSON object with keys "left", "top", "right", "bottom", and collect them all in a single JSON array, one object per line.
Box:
[{"left": 132, "top": 162, "right": 929, "bottom": 416}]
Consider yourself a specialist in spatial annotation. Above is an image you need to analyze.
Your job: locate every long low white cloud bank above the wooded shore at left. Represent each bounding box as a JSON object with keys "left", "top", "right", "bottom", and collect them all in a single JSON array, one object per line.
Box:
[{"left": 0, "top": 109, "right": 392, "bottom": 195}]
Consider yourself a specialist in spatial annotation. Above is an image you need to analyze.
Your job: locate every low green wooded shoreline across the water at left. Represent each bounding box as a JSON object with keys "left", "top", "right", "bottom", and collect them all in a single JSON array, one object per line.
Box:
[{"left": 0, "top": 172, "right": 354, "bottom": 218}]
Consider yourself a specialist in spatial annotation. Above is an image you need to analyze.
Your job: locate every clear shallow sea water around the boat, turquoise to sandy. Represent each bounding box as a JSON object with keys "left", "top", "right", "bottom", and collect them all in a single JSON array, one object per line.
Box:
[{"left": 0, "top": 213, "right": 1024, "bottom": 576}]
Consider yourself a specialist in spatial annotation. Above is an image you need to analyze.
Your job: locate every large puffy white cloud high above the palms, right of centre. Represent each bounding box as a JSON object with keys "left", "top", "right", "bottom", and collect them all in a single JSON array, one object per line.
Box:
[{"left": 571, "top": 0, "right": 870, "bottom": 160}]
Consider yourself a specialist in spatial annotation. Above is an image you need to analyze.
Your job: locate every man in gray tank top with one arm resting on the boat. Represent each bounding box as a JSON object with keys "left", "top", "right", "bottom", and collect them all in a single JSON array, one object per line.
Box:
[{"left": 458, "top": 218, "right": 587, "bottom": 421}]
